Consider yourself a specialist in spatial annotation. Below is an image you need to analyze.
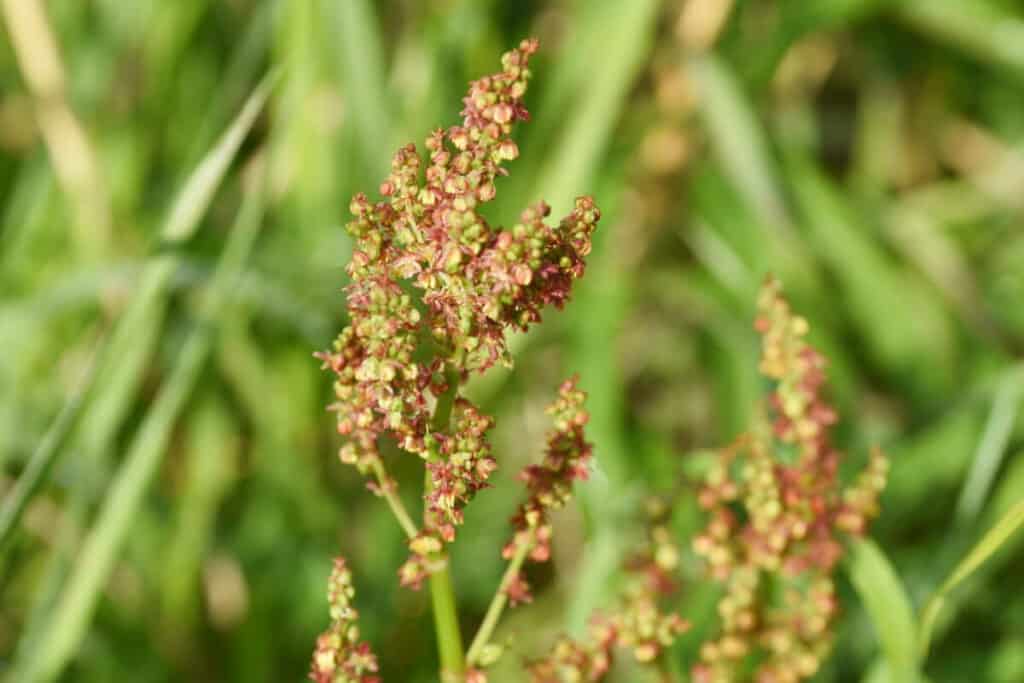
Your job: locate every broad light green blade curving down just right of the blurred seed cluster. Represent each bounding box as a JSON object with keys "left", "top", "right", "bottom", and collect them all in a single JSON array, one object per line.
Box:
[{"left": 847, "top": 539, "right": 921, "bottom": 683}]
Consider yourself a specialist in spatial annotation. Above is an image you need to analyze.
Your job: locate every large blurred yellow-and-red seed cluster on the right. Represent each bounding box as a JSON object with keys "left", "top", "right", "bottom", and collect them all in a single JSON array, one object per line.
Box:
[{"left": 693, "top": 280, "right": 888, "bottom": 683}]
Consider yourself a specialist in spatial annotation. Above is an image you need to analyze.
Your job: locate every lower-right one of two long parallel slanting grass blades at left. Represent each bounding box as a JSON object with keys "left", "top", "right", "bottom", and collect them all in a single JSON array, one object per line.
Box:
[{"left": 18, "top": 158, "right": 263, "bottom": 681}]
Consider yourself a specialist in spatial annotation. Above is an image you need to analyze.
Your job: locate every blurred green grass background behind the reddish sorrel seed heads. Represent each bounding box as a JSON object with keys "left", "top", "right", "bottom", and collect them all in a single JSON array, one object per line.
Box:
[{"left": 0, "top": 0, "right": 1024, "bottom": 683}]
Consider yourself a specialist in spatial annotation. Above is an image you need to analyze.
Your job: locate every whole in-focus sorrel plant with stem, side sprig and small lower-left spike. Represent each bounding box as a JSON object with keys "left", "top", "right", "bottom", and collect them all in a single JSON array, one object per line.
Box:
[{"left": 310, "top": 40, "right": 600, "bottom": 681}]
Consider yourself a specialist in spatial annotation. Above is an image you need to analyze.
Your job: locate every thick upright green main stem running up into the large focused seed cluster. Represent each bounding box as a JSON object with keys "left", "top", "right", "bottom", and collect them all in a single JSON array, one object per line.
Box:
[{"left": 424, "top": 362, "right": 466, "bottom": 683}]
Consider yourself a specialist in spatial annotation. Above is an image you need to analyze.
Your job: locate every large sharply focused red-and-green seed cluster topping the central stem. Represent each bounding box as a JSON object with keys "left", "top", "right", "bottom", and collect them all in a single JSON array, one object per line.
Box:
[{"left": 318, "top": 40, "right": 601, "bottom": 588}]
